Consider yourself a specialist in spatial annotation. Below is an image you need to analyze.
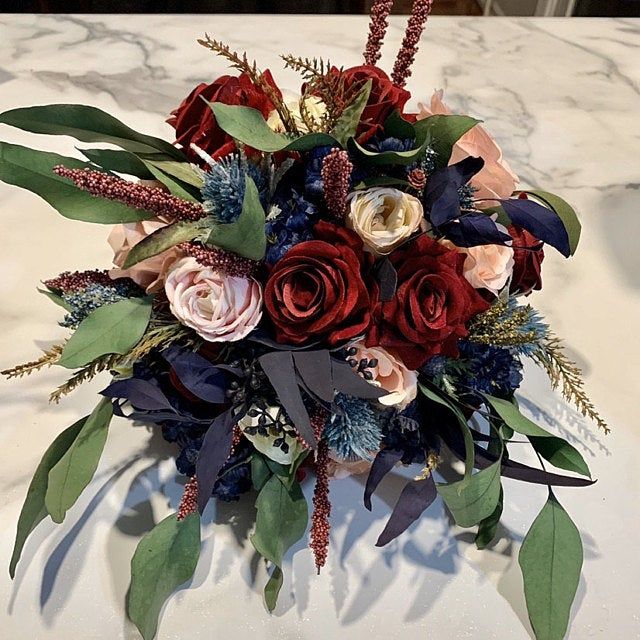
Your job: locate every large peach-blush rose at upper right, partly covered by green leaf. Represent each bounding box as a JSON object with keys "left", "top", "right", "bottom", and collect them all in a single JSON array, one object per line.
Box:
[{"left": 416, "top": 89, "right": 518, "bottom": 208}]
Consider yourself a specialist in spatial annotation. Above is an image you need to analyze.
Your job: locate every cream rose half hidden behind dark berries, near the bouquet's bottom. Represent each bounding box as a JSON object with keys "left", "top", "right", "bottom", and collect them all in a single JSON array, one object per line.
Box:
[{"left": 238, "top": 405, "right": 304, "bottom": 464}]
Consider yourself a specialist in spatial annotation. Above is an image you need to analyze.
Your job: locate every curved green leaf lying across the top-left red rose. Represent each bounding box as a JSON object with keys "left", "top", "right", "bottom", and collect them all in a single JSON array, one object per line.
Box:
[{"left": 207, "top": 102, "right": 336, "bottom": 153}]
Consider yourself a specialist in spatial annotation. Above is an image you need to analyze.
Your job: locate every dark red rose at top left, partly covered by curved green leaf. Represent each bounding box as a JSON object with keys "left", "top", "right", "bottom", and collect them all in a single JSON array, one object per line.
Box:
[{"left": 167, "top": 71, "right": 280, "bottom": 164}]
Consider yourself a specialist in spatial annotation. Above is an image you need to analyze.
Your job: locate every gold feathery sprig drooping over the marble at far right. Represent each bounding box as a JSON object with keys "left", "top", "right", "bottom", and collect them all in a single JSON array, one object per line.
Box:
[{"left": 531, "top": 333, "right": 611, "bottom": 433}]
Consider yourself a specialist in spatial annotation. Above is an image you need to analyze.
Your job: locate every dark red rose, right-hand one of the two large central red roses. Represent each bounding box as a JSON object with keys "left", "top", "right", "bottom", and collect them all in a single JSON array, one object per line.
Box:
[{"left": 366, "top": 235, "right": 490, "bottom": 369}]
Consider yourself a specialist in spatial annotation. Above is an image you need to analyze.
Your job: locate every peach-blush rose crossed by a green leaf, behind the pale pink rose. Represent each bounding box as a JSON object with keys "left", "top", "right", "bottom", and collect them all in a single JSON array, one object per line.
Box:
[{"left": 107, "top": 217, "right": 184, "bottom": 293}]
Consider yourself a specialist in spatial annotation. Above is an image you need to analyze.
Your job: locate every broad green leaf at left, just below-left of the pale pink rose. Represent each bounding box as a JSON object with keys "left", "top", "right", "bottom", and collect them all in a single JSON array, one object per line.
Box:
[{"left": 57, "top": 297, "right": 151, "bottom": 369}]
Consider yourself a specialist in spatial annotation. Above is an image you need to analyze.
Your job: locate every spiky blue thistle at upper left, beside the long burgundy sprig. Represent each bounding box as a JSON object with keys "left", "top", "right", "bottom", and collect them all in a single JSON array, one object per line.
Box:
[{"left": 202, "top": 153, "right": 267, "bottom": 224}]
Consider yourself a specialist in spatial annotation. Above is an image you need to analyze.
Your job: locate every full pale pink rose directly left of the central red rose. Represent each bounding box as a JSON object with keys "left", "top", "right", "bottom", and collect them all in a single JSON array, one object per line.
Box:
[{"left": 164, "top": 257, "right": 262, "bottom": 342}]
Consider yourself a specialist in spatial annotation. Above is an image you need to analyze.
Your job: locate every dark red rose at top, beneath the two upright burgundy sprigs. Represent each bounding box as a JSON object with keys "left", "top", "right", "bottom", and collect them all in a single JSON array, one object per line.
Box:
[{"left": 343, "top": 65, "right": 411, "bottom": 143}]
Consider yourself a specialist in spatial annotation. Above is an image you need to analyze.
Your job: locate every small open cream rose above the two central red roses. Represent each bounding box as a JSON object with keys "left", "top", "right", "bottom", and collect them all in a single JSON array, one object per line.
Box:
[{"left": 346, "top": 187, "right": 423, "bottom": 256}]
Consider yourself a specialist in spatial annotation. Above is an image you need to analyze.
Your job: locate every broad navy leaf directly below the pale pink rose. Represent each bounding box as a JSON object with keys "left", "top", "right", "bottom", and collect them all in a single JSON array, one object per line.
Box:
[{"left": 162, "top": 348, "right": 226, "bottom": 404}]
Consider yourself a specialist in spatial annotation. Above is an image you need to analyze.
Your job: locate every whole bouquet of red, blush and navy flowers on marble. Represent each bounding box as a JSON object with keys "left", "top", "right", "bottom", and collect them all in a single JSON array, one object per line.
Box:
[{"left": 0, "top": 0, "right": 608, "bottom": 640}]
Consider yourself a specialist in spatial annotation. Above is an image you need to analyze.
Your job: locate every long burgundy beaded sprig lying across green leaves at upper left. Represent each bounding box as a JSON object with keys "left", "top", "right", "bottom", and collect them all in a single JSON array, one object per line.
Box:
[{"left": 53, "top": 165, "right": 207, "bottom": 220}]
